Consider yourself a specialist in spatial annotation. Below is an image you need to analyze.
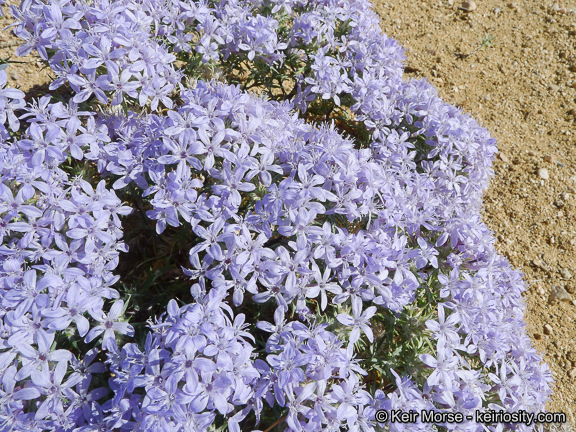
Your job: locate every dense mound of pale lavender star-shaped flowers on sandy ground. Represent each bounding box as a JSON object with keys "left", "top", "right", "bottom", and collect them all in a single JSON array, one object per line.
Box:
[{"left": 0, "top": 0, "right": 551, "bottom": 431}]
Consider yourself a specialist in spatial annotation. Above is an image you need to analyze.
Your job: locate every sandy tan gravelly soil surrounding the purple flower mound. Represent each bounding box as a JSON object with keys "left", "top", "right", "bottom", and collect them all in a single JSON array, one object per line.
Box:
[{"left": 0, "top": 0, "right": 576, "bottom": 431}]
